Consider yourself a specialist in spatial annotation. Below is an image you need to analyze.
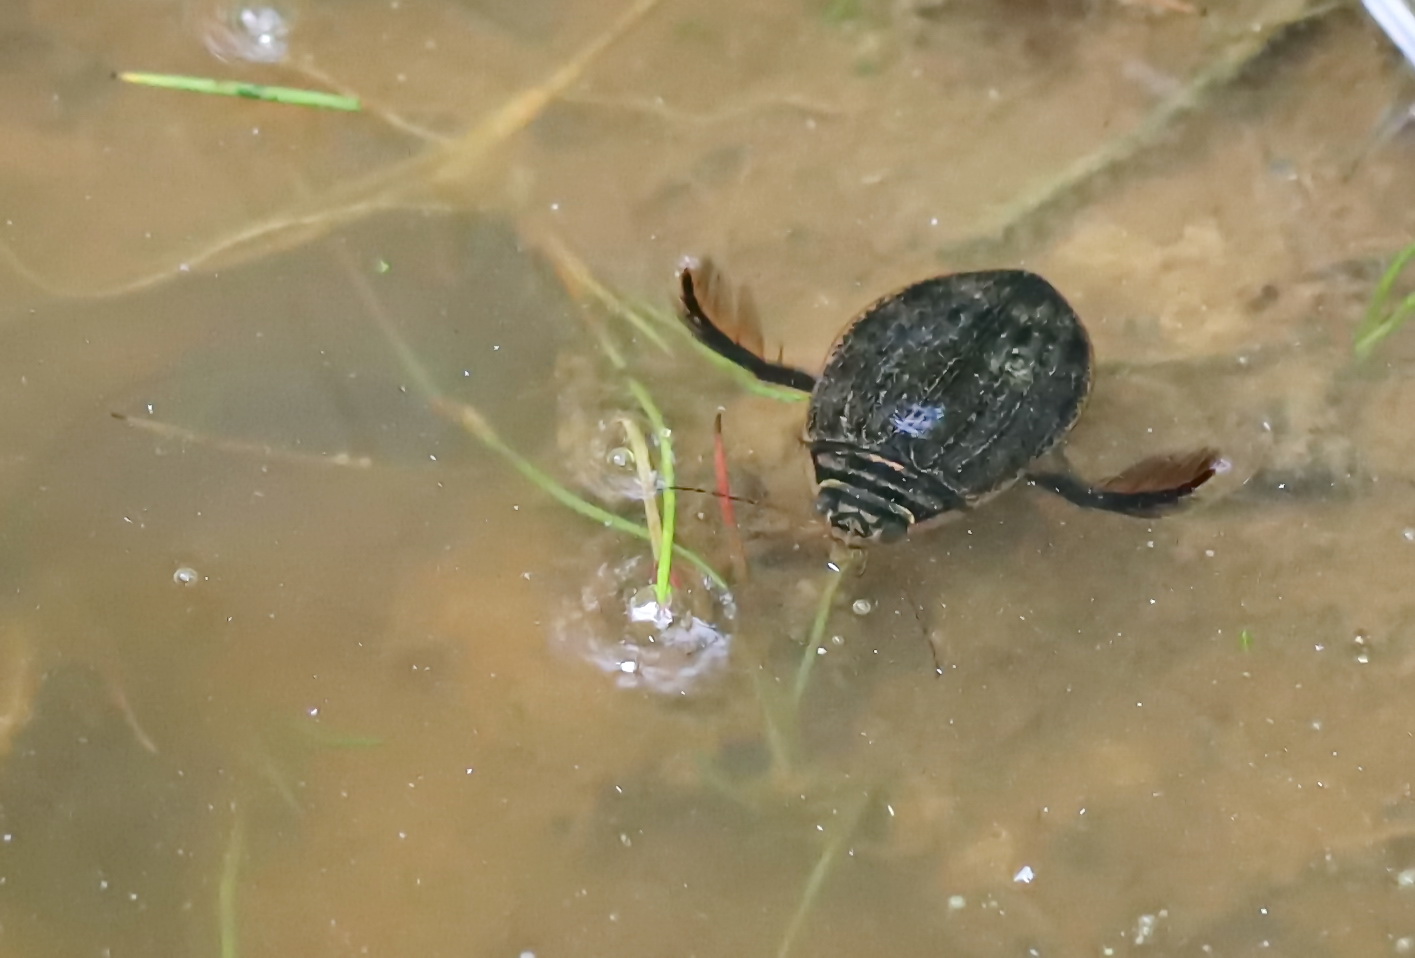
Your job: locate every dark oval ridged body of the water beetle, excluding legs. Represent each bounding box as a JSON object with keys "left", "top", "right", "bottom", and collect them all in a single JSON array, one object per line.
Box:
[{"left": 807, "top": 270, "right": 1091, "bottom": 535}]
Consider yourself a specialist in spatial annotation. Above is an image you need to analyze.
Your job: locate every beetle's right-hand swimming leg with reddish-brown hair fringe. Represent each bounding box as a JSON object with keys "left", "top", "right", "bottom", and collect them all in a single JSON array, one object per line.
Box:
[{"left": 1026, "top": 447, "right": 1223, "bottom": 518}]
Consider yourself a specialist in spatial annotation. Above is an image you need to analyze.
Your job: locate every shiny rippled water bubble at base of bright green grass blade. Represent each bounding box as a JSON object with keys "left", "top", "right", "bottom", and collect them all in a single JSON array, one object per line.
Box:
[{"left": 550, "top": 555, "right": 737, "bottom": 695}]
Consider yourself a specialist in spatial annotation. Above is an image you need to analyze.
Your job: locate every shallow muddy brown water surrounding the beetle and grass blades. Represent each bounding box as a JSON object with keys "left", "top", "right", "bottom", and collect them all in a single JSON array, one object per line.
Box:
[{"left": 0, "top": 0, "right": 1415, "bottom": 958}]
